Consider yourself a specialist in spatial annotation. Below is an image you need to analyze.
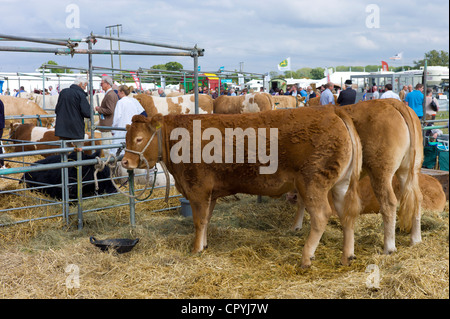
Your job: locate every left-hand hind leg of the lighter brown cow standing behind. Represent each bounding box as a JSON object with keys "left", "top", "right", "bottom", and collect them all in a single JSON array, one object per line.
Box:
[{"left": 370, "top": 173, "right": 397, "bottom": 254}]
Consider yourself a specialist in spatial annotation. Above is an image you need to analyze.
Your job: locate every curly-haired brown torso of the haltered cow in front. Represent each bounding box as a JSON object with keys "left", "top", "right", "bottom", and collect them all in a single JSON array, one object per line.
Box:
[{"left": 163, "top": 108, "right": 352, "bottom": 196}]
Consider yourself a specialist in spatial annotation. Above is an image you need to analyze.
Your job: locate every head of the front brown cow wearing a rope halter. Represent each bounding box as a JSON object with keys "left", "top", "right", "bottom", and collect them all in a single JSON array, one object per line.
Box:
[{"left": 122, "top": 113, "right": 162, "bottom": 169}]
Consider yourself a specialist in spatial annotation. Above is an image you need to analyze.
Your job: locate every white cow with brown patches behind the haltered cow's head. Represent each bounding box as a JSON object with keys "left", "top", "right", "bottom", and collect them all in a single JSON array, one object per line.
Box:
[{"left": 134, "top": 94, "right": 213, "bottom": 116}]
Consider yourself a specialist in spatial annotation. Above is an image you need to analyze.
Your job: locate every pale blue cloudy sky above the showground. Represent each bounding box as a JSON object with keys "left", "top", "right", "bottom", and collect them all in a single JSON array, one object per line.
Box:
[{"left": 0, "top": 0, "right": 449, "bottom": 73}]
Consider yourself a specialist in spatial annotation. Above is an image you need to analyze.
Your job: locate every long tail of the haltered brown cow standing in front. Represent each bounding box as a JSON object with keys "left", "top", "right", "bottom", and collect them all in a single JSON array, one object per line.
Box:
[{"left": 336, "top": 108, "right": 362, "bottom": 228}]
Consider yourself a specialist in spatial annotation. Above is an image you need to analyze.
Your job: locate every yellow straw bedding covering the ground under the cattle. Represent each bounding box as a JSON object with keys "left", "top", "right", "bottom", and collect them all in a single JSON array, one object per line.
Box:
[{"left": 0, "top": 172, "right": 449, "bottom": 299}]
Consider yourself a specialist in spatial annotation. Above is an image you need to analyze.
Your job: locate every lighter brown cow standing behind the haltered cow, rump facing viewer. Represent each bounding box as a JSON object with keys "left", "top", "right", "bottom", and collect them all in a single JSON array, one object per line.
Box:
[{"left": 296, "top": 99, "right": 423, "bottom": 254}]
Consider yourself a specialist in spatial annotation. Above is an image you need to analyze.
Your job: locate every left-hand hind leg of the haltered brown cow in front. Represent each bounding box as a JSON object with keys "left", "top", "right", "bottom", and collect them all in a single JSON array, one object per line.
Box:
[{"left": 302, "top": 189, "right": 331, "bottom": 267}]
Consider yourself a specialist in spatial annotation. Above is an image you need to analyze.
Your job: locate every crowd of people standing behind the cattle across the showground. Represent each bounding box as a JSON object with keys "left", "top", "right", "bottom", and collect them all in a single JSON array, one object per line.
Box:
[{"left": 0, "top": 75, "right": 439, "bottom": 167}]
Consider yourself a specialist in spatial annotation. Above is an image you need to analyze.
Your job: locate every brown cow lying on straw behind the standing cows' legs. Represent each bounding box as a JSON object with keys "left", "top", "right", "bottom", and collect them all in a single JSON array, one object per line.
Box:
[{"left": 286, "top": 173, "right": 447, "bottom": 224}]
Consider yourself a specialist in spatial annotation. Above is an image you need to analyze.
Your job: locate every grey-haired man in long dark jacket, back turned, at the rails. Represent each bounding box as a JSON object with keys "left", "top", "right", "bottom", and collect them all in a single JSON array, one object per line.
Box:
[{"left": 55, "top": 77, "right": 91, "bottom": 145}]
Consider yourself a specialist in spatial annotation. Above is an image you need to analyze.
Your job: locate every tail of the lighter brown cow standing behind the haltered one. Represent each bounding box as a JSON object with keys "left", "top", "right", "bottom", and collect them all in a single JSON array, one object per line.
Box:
[{"left": 392, "top": 101, "right": 423, "bottom": 231}]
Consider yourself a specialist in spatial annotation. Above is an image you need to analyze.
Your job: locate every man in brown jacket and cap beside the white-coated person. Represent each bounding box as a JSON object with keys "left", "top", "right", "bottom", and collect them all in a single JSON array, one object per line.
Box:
[{"left": 95, "top": 75, "right": 119, "bottom": 145}]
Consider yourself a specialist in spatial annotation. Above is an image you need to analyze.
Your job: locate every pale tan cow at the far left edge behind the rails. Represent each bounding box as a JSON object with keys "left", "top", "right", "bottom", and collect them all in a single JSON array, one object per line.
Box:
[{"left": 0, "top": 95, "right": 54, "bottom": 126}]
